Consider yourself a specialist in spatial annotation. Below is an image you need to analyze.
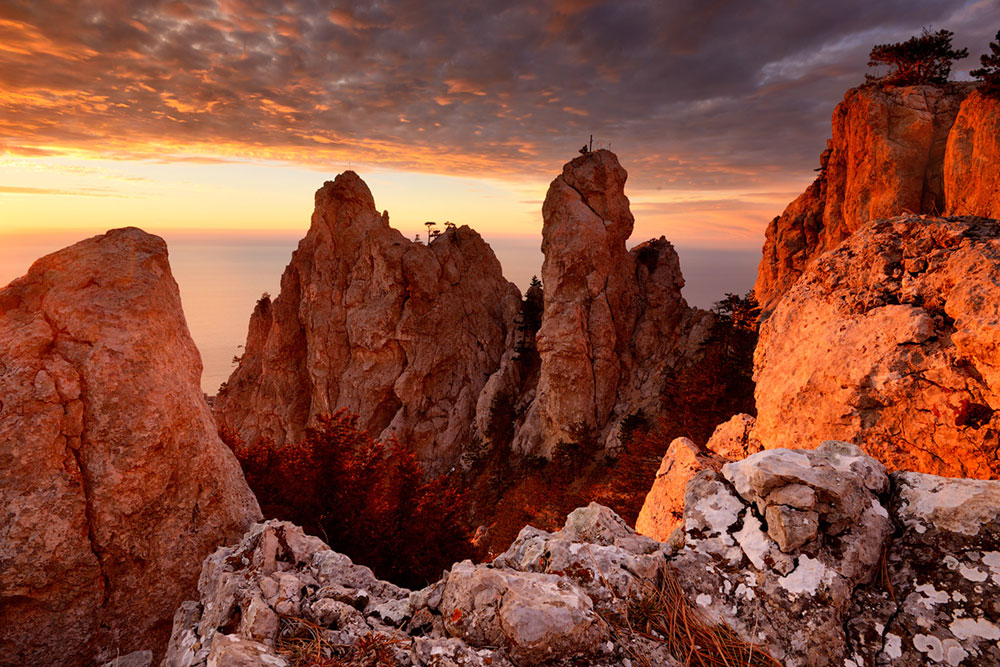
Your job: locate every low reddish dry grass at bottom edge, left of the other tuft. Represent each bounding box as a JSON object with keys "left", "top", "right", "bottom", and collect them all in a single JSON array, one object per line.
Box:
[{"left": 274, "top": 616, "right": 404, "bottom": 667}]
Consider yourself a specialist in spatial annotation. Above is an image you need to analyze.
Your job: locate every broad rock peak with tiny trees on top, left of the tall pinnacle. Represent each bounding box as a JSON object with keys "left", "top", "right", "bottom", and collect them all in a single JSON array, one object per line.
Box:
[{"left": 215, "top": 172, "right": 520, "bottom": 473}]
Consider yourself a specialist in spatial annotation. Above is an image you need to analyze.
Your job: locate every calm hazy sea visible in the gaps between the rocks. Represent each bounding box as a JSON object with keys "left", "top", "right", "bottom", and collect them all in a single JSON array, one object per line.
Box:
[{"left": 0, "top": 230, "right": 760, "bottom": 394}]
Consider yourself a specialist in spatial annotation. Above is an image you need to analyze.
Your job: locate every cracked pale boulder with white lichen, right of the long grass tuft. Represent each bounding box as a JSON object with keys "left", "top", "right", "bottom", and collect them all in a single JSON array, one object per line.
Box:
[{"left": 671, "top": 442, "right": 892, "bottom": 667}]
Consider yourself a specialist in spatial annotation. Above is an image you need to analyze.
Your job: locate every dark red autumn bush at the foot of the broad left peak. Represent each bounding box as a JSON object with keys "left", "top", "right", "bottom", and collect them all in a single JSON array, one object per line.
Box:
[{"left": 220, "top": 410, "right": 474, "bottom": 588}]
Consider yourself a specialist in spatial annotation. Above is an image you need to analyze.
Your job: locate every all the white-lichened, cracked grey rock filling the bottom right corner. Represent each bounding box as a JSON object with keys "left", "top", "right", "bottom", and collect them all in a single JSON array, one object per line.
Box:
[{"left": 672, "top": 442, "right": 1000, "bottom": 667}]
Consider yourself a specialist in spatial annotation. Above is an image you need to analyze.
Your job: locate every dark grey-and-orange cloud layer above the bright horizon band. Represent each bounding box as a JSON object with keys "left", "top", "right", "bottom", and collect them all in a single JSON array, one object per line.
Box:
[{"left": 0, "top": 0, "right": 1000, "bottom": 189}]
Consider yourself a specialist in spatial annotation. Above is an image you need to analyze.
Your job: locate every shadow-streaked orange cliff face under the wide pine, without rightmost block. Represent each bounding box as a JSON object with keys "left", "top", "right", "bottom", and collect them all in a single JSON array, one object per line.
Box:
[{"left": 754, "top": 84, "right": 976, "bottom": 312}]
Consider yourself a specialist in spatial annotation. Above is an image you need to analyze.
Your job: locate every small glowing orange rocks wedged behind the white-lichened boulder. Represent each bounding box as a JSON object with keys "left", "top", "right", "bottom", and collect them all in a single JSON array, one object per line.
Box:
[{"left": 635, "top": 414, "right": 763, "bottom": 542}]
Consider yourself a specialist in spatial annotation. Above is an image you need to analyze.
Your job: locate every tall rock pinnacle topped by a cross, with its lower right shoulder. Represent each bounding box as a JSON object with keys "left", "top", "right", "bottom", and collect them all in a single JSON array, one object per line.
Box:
[{"left": 477, "top": 150, "right": 713, "bottom": 457}]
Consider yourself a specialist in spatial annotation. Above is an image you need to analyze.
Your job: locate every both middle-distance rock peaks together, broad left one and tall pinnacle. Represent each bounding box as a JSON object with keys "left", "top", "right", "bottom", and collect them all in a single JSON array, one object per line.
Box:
[{"left": 223, "top": 150, "right": 714, "bottom": 473}]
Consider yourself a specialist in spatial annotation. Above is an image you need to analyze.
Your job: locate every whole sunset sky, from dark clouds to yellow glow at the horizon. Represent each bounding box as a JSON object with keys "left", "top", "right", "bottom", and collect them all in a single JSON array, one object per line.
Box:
[{"left": 0, "top": 0, "right": 1000, "bottom": 386}]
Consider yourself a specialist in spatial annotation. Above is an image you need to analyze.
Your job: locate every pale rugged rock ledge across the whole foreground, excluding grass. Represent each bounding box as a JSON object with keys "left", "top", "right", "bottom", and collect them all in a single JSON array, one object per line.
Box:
[{"left": 164, "top": 440, "right": 1000, "bottom": 667}]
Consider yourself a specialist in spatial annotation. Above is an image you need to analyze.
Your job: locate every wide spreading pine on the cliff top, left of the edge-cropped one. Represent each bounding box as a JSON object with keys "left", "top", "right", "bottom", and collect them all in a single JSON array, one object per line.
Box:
[{"left": 865, "top": 28, "right": 969, "bottom": 86}]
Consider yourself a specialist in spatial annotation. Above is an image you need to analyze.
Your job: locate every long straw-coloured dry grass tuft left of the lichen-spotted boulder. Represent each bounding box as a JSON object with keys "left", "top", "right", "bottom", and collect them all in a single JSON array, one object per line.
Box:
[{"left": 611, "top": 570, "right": 781, "bottom": 667}]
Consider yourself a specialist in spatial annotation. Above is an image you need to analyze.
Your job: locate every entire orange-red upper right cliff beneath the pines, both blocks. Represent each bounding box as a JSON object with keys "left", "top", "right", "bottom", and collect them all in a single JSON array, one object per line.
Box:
[{"left": 755, "top": 83, "right": 1000, "bottom": 312}]
